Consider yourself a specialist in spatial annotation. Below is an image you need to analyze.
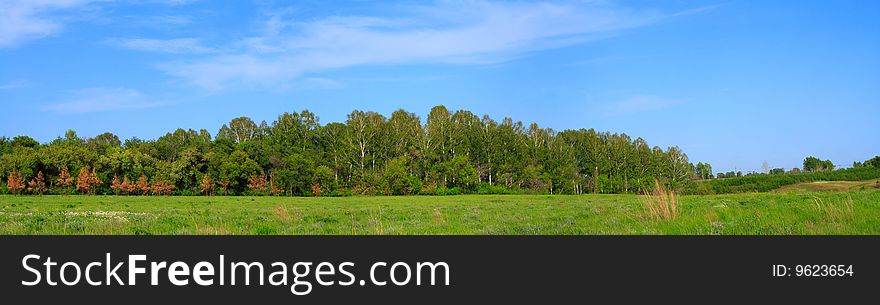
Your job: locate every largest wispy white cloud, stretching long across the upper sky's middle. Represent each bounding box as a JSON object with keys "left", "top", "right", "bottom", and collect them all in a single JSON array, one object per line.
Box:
[{"left": 160, "top": 1, "right": 664, "bottom": 90}]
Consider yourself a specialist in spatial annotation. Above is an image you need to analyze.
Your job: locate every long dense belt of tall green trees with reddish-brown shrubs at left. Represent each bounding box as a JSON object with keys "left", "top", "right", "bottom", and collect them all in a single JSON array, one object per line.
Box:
[{"left": 0, "top": 106, "right": 713, "bottom": 196}]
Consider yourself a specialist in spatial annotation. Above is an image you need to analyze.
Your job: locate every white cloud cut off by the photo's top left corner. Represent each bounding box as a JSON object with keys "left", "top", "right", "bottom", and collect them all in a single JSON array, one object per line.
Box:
[{"left": 0, "top": 0, "right": 105, "bottom": 48}]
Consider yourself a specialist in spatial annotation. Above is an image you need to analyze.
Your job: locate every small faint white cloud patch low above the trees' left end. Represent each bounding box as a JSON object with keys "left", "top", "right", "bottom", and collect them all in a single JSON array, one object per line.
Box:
[{"left": 43, "top": 88, "right": 163, "bottom": 114}]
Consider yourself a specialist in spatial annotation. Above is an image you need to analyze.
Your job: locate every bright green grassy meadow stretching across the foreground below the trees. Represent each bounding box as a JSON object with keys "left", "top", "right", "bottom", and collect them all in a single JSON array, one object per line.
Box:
[{"left": 0, "top": 189, "right": 880, "bottom": 235}]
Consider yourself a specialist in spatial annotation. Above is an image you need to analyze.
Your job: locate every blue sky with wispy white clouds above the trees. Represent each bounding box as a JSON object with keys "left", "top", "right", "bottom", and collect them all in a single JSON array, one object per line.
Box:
[{"left": 0, "top": 0, "right": 880, "bottom": 171}]
